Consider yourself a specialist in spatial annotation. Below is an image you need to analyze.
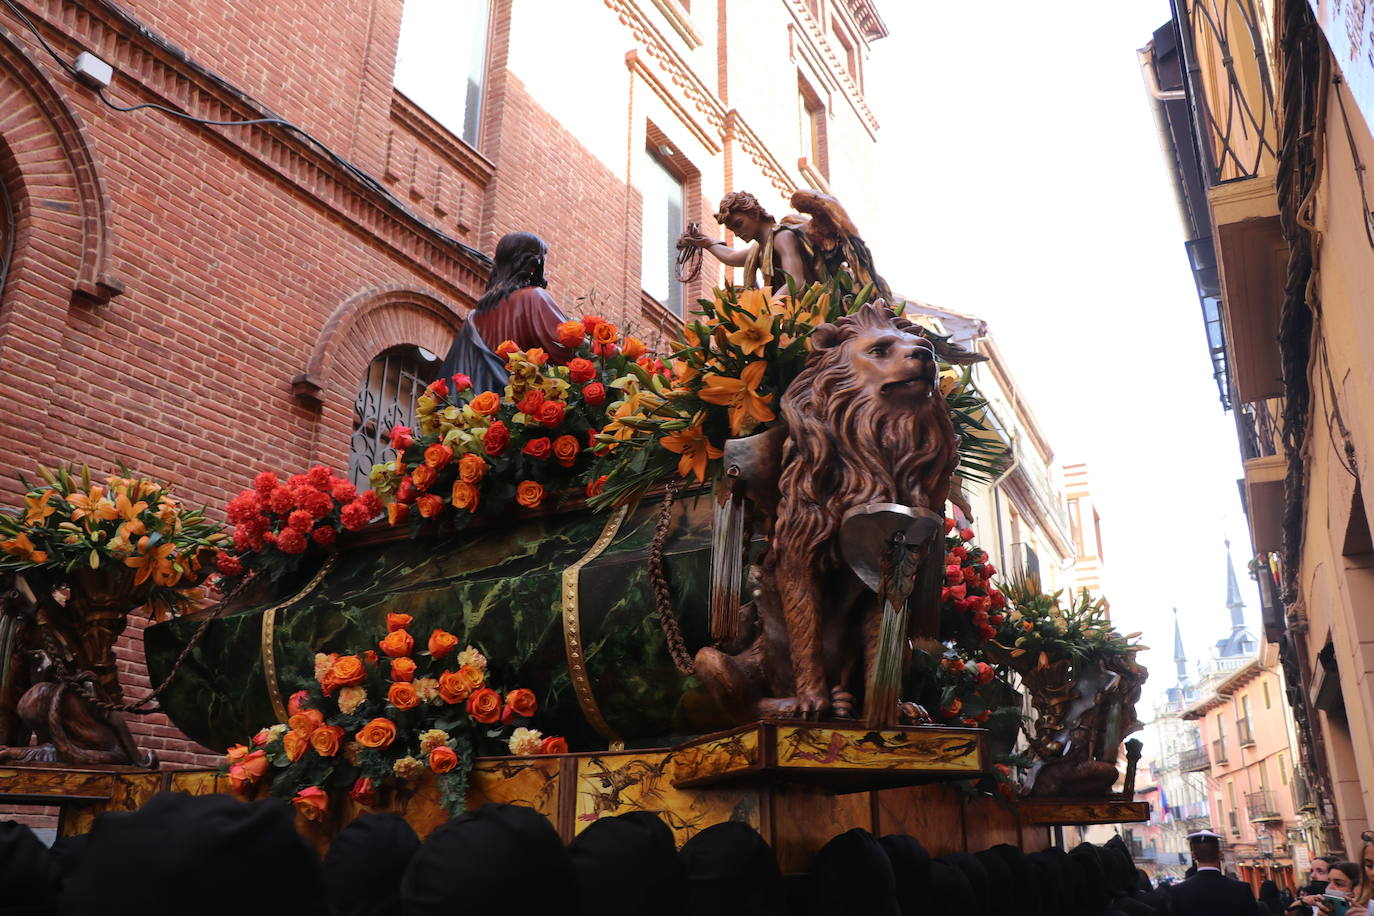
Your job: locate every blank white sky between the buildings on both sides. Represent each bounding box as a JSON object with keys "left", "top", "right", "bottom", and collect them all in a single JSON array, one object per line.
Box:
[{"left": 860, "top": 0, "right": 1260, "bottom": 717}]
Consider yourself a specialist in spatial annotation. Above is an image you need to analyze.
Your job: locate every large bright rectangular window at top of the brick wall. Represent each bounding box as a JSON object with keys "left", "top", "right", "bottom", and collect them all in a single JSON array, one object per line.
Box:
[{"left": 393, "top": 0, "right": 488, "bottom": 146}]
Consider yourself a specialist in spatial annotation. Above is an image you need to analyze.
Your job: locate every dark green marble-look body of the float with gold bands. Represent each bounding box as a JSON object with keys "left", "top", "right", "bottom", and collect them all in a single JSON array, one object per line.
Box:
[{"left": 144, "top": 496, "right": 723, "bottom": 750}]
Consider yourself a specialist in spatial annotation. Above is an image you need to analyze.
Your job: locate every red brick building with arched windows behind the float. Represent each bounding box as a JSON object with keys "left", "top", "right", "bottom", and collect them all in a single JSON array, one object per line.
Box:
[{"left": 0, "top": 0, "right": 885, "bottom": 791}]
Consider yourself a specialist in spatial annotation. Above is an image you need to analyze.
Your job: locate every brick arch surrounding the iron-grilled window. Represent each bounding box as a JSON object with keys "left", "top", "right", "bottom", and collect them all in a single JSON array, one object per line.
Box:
[{"left": 291, "top": 286, "right": 463, "bottom": 468}]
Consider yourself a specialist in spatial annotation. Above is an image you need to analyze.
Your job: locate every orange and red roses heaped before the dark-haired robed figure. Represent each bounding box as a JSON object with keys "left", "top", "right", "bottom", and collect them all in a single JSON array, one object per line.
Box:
[{"left": 371, "top": 314, "right": 669, "bottom": 530}]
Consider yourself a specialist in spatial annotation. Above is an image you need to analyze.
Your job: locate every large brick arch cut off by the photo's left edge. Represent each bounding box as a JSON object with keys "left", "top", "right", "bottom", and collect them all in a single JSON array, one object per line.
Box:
[{"left": 0, "top": 26, "right": 124, "bottom": 304}]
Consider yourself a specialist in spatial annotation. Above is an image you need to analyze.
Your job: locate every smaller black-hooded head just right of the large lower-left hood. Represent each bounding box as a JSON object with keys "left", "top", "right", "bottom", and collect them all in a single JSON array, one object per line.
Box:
[{"left": 320, "top": 814, "right": 420, "bottom": 916}]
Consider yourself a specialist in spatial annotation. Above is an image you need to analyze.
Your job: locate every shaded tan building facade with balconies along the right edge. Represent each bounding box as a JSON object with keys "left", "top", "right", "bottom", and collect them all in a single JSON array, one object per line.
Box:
[{"left": 1142, "top": 0, "right": 1374, "bottom": 856}]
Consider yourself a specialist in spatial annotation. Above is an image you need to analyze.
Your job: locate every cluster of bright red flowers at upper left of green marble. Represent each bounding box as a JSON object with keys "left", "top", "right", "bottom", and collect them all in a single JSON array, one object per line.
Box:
[{"left": 216, "top": 464, "right": 382, "bottom": 581}]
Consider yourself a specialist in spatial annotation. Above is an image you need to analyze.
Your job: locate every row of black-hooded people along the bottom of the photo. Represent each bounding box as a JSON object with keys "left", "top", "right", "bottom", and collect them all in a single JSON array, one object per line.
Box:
[{"left": 0, "top": 792, "right": 1374, "bottom": 916}]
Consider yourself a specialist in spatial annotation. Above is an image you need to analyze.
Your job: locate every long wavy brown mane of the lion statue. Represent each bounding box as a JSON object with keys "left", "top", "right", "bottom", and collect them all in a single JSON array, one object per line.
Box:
[{"left": 769, "top": 305, "right": 958, "bottom": 569}]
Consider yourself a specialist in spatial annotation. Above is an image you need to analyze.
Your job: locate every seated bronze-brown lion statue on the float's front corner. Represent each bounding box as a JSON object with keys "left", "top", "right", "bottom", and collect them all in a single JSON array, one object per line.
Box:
[{"left": 695, "top": 302, "right": 958, "bottom": 721}]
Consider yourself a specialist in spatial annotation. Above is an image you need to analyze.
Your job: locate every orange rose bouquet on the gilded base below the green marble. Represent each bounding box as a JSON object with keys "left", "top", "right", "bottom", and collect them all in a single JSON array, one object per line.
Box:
[{"left": 224, "top": 614, "right": 567, "bottom": 820}]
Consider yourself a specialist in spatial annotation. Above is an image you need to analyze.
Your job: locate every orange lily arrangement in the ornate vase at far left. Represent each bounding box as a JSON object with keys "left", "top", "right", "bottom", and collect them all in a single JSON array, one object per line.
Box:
[{"left": 0, "top": 466, "right": 228, "bottom": 617}]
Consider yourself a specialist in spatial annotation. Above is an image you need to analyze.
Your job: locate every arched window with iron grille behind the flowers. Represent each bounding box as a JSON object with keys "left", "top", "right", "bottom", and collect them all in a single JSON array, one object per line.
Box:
[{"left": 348, "top": 345, "right": 440, "bottom": 490}]
